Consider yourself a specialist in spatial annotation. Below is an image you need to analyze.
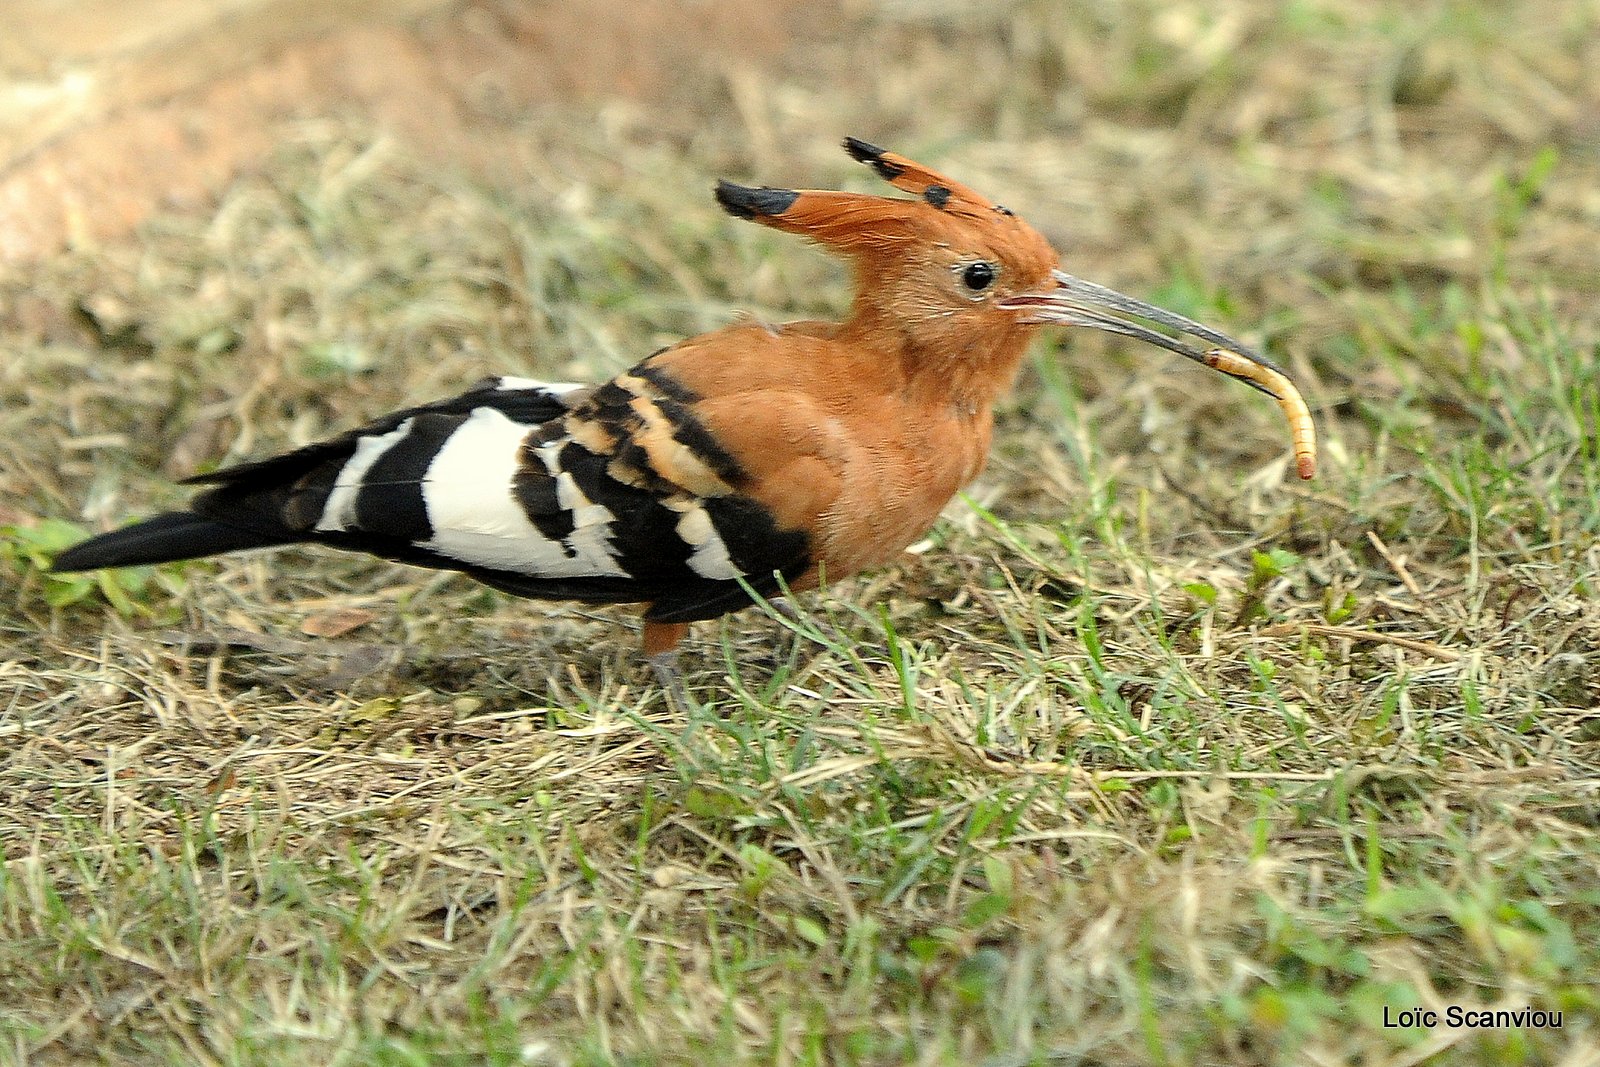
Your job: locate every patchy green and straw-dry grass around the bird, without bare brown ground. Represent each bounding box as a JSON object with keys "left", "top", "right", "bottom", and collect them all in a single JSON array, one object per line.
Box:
[{"left": 0, "top": 0, "right": 1600, "bottom": 1067}]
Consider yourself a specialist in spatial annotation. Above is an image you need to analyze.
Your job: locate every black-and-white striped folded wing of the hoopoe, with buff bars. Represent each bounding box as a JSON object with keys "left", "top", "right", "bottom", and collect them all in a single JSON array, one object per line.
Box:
[{"left": 192, "top": 371, "right": 810, "bottom": 622}]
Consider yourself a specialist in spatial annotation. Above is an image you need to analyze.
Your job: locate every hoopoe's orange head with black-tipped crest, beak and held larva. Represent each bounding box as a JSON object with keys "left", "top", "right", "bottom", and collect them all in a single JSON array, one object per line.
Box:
[{"left": 717, "top": 138, "right": 1312, "bottom": 477}]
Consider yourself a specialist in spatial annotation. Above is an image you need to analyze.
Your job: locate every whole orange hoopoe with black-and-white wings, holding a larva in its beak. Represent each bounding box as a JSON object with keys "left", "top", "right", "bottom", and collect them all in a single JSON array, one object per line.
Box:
[{"left": 54, "top": 138, "right": 1314, "bottom": 685}]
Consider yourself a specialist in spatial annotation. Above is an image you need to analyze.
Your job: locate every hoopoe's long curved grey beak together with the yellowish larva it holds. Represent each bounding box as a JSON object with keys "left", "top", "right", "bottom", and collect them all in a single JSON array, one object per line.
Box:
[{"left": 998, "top": 270, "right": 1317, "bottom": 478}]
